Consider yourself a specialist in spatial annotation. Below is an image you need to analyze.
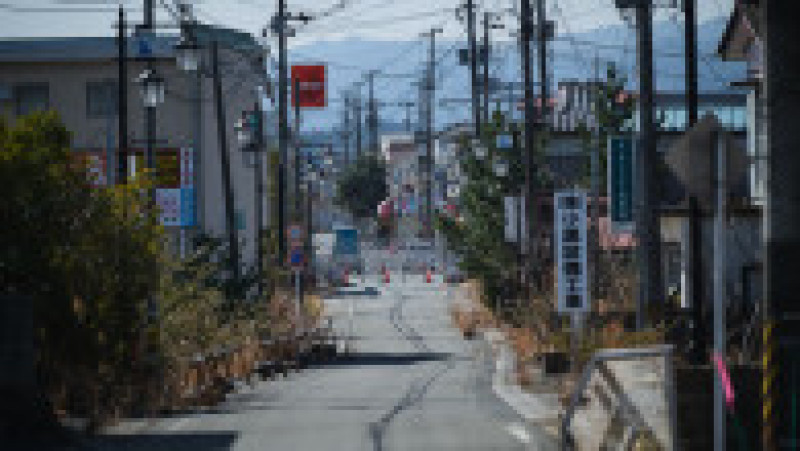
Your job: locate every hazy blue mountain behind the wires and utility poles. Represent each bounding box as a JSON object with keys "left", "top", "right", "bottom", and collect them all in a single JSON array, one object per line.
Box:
[{"left": 289, "top": 17, "right": 744, "bottom": 131}]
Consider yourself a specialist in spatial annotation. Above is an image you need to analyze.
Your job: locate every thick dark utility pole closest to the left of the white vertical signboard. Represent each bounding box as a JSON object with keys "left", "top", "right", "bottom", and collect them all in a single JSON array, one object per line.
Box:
[{"left": 520, "top": 0, "right": 536, "bottom": 294}]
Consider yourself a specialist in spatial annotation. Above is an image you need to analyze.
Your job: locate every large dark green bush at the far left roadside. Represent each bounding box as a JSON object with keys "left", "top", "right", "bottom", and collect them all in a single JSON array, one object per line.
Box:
[{"left": 0, "top": 112, "right": 163, "bottom": 420}]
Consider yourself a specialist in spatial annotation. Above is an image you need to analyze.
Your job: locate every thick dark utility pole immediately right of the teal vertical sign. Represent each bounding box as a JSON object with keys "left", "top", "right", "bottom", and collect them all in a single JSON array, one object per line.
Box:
[{"left": 636, "top": 0, "right": 663, "bottom": 330}]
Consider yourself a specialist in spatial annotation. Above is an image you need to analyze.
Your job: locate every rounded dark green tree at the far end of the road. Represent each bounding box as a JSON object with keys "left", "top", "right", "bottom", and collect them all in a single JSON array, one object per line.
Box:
[{"left": 336, "top": 155, "right": 389, "bottom": 218}]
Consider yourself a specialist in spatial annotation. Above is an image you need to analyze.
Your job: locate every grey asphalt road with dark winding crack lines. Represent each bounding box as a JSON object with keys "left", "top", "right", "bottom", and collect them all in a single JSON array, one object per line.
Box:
[{"left": 75, "top": 275, "right": 540, "bottom": 451}]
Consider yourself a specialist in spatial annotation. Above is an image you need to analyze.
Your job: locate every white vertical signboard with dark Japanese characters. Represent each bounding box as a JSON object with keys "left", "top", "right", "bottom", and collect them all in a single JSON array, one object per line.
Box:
[{"left": 554, "top": 190, "right": 589, "bottom": 313}]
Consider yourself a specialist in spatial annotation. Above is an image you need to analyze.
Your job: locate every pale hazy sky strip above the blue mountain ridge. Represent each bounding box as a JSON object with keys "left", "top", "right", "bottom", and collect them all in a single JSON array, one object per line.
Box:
[{"left": 0, "top": 0, "right": 733, "bottom": 45}]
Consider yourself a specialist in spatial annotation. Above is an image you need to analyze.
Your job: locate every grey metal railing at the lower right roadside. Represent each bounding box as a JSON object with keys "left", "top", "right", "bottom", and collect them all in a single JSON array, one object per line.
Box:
[{"left": 560, "top": 345, "right": 678, "bottom": 451}]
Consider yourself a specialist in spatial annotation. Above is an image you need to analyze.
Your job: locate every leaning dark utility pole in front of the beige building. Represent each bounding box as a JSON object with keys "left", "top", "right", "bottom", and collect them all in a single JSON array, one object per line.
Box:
[{"left": 211, "top": 40, "right": 240, "bottom": 282}]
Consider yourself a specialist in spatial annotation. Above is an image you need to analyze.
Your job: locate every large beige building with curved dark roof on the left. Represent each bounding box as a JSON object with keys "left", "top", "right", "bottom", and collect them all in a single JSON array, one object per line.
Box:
[{"left": 0, "top": 27, "right": 268, "bottom": 263}]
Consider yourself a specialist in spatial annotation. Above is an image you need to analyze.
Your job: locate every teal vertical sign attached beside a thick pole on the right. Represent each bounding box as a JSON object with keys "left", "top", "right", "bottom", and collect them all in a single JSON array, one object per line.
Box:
[{"left": 608, "top": 135, "right": 635, "bottom": 231}]
